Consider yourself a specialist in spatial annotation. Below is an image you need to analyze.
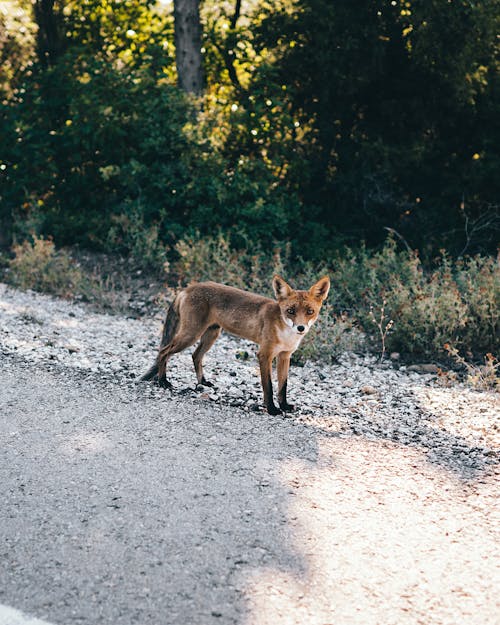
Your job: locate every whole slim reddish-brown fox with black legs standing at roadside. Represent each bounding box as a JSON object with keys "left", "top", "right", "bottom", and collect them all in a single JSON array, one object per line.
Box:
[{"left": 140, "top": 275, "right": 330, "bottom": 415}]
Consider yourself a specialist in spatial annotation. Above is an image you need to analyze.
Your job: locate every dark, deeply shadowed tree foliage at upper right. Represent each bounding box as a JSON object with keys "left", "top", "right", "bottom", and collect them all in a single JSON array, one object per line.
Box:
[{"left": 246, "top": 0, "right": 500, "bottom": 254}]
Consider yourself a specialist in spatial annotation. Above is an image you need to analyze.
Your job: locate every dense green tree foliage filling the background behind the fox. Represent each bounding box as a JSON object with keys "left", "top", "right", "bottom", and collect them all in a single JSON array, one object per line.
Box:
[{"left": 0, "top": 0, "right": 500, "bottom": 266}]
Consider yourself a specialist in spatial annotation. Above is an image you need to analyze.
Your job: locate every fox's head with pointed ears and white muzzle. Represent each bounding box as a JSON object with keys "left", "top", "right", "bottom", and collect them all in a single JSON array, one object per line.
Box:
[{"left": 273, "top": 275, "right": 330, "bottom": 334}]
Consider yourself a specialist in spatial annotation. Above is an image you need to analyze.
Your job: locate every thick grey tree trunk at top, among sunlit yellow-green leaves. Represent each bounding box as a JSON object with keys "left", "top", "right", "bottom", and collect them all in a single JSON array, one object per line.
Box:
[{"left": 174, "top": 0, "right": 203, "bottom": 95}]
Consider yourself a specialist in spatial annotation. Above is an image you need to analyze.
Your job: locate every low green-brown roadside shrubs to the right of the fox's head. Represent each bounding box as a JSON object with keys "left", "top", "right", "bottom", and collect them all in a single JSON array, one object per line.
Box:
[{"left": 334, "top": 239, "right": 500, "bottom": 358}]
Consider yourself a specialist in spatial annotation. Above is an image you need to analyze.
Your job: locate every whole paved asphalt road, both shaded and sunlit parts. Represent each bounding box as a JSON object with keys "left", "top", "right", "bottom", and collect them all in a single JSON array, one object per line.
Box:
[{"left": 0, "top": 356, "right": 500, "bottom": 625}]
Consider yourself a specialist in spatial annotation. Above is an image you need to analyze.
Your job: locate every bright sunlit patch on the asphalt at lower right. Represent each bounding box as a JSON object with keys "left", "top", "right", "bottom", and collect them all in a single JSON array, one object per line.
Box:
[{"left": 241, "top": 439, "right": 500, "bottom": 625}]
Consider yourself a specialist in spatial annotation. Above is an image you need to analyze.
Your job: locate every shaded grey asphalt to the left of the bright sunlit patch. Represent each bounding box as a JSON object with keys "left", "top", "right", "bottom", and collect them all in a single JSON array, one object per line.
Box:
[{"left": 0, "top": 358, "right": 316, "bottom": 625}]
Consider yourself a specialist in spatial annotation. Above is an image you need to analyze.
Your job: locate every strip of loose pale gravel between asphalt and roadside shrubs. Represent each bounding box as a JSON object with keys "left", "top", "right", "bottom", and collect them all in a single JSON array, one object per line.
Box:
[{"left": 0, "top": 284, "right": 500, "bottom": 478}]
